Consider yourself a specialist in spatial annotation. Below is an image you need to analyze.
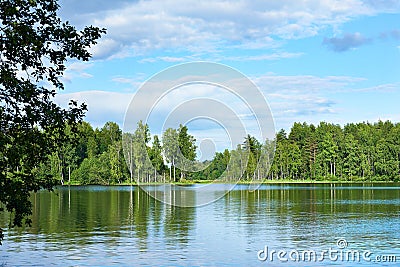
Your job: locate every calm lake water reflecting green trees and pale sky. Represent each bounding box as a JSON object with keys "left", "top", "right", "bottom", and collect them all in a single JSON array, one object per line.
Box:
[{"left": 0, "top": 184, "right": 400, "bottom": 266}]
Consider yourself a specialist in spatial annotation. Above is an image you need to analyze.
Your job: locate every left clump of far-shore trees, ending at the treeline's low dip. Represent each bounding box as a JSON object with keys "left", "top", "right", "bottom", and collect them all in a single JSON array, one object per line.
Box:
[{"left": 37, "top": 122, "right": 196, "bottom": 184}]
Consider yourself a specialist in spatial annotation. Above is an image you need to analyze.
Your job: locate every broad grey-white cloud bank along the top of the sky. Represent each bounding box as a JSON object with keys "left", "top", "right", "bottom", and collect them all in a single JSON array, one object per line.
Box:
[{"left": 60, "top": 0, "right": 399, "bottom": 61}]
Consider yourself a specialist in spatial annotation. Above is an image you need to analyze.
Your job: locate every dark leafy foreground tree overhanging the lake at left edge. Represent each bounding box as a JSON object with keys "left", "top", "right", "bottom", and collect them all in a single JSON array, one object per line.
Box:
[{"left": 0, "top": 0, "right": 105, "bottom": 244}]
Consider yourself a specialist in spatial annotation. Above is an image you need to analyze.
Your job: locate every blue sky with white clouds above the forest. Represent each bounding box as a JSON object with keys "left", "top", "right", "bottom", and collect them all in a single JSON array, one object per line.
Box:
[{"left": 56, "top": 0, "right": 400, "bottom": 154}]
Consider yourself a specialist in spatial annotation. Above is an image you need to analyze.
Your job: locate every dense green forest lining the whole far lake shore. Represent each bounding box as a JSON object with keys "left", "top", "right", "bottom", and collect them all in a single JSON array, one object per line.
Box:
[{"left": 38, "top": 121, "right": 400, "bottom": 184}]
